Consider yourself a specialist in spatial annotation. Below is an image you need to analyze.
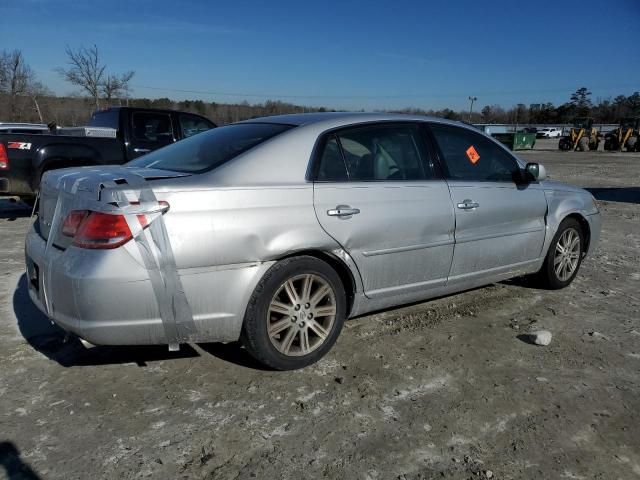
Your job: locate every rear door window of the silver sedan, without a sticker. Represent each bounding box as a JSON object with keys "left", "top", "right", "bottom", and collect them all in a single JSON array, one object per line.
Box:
[{"left": 317, "top": 125, "right": 434, "bottom": 182}]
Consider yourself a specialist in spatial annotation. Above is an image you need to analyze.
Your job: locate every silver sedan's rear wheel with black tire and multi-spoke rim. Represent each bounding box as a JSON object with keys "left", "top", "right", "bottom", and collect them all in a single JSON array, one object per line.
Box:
[{"left": 242, "top": 256, "right": 346, "bottom": 370}]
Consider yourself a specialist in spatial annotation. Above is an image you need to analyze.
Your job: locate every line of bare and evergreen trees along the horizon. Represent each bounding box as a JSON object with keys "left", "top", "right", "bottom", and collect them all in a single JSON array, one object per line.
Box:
[{"left": 0, "top": 45, "right": 640, "bottom": 126}]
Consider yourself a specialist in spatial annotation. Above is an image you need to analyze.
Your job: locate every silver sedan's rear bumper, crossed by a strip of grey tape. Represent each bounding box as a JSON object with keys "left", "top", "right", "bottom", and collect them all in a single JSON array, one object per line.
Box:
[{"left": 25, "top": 228, "right": 274, "bottom": 345}]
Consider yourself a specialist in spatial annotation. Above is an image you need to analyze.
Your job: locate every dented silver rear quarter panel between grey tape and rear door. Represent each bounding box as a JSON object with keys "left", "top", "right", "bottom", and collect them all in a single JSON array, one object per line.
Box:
[{"left": 125, "top": 184, "right": 339, "bottom": 269}]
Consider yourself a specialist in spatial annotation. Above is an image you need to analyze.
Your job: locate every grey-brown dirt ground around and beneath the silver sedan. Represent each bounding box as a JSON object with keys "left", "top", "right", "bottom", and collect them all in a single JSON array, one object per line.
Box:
[{"left": 0, "top": 141, "right": 640, "bottom": 480}]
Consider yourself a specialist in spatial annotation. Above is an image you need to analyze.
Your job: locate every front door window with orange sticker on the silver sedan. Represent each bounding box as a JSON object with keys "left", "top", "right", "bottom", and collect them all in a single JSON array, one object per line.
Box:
[{"left": 429, "top": 123, "right": 519, "bottom": 182}]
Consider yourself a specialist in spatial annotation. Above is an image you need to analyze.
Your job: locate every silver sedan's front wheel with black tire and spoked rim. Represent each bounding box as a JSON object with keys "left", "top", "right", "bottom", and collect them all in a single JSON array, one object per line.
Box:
[{"left": 537, "top": 218, "right": 584, "bottom": 290}]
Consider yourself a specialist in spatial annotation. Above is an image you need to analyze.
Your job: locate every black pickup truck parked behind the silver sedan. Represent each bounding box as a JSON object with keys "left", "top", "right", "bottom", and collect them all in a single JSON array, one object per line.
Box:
[{"left": 0, "top": 107, "right": 216, "bottom": 202}]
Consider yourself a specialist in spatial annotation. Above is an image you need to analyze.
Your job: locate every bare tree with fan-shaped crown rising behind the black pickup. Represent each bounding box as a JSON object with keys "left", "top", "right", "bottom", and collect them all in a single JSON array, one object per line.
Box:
[{"left": 56, "top": 45, "right": 107, "bottom": 109}]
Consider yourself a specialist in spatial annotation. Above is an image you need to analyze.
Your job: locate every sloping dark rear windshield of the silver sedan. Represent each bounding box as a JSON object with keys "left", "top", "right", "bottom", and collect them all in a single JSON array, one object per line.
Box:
[{"left": 127, "top": 123, "right": 293, "bottom": 173}]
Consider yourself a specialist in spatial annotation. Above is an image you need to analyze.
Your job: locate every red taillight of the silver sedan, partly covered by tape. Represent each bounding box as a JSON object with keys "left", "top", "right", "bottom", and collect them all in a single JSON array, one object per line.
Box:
[{"left": 62, "top": 202, "right": 169, "bottom": 249}]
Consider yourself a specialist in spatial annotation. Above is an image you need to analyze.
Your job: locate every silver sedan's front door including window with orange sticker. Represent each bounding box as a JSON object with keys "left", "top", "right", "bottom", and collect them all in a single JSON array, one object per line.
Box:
[{"left": 430, "top": 123, "right": 547, "bottom": 282}]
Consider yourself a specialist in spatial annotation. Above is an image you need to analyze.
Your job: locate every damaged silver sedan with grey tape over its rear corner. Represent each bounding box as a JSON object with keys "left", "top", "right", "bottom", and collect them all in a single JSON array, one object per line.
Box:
[{"left": 26, "top": 113, "right": 600, "bottom": 370}]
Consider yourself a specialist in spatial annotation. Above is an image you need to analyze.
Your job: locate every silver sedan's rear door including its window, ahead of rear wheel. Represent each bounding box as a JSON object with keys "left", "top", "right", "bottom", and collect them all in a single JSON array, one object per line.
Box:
[{"left": 314, "top": 123, "right": 454, "bottom": 298}]
